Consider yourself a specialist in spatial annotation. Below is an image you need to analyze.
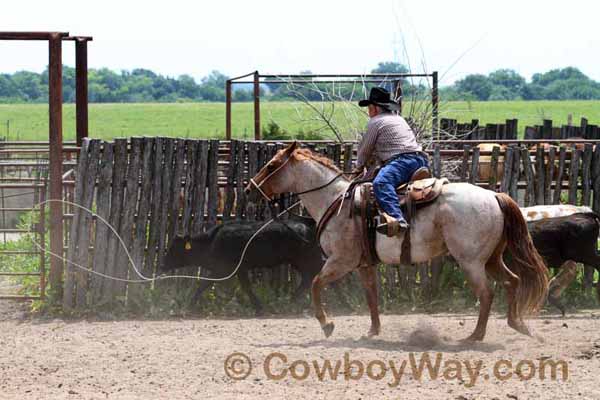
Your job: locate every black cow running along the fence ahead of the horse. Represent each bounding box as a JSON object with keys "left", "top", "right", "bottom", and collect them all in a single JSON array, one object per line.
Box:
[{"left": 161, "top": 216, "right": 339, "bottom": 313}]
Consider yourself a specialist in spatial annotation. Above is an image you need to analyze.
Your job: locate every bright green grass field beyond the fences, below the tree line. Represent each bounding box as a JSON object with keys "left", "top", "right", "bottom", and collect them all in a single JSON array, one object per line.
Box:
[{"left": 0, "top": 101, "right": 600, "bottom": 140}]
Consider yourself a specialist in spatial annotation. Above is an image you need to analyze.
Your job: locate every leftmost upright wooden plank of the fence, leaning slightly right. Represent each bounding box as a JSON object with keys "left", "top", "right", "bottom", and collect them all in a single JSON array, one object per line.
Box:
[{"left": 61, "top": 140, "right": 90, "bottom": 311}]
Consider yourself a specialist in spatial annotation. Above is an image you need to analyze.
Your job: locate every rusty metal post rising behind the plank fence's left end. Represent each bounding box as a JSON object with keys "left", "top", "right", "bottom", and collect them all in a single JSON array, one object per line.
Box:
[{"left": 75, "top": 38, "right": 89, "bottom": 146}]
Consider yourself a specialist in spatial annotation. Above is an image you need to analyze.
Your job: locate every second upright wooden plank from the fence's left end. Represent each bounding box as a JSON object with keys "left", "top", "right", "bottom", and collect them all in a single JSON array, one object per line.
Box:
[{"left": 75, "top": 138, "right": 100, "bottom": 308}]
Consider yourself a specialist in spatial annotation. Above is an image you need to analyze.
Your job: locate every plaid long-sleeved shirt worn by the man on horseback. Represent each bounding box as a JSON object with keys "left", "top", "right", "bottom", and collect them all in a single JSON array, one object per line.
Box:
[{"left": 356, "top": 113, "right": 423, "bottom": 168}]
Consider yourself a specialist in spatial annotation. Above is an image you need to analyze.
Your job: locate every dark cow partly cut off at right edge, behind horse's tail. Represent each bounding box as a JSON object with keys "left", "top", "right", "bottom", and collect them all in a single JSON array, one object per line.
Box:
[{"left": 527, "top": 213, "right": 600, "bottom": 315}]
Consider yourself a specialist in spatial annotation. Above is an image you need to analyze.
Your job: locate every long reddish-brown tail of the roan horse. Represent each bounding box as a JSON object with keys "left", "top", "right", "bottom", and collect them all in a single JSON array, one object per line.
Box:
[{"left": 496, "top": 193, "right": 548, "bottom": 316}]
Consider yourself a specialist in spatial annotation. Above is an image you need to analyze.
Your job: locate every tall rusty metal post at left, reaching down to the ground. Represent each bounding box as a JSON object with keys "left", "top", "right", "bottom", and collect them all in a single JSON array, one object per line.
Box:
[{"left": 48, "top": 34, "right": 63, "bottom": 300}]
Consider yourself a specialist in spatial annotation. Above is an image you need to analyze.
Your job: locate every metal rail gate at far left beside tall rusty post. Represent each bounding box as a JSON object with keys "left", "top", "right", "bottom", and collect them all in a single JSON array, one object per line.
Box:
[{"left": 0, "top": 141, "right": 76, "bottom": 300}]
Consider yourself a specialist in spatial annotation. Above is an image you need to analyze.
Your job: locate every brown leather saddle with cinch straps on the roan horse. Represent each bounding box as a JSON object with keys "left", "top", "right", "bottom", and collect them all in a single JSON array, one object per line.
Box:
[{"left": 351, "top": 167, "right": 448, "bottom": 265}]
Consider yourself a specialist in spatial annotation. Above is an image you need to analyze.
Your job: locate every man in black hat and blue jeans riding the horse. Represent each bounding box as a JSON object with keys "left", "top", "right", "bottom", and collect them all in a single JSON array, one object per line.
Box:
[{"left": 355, "top": 87, "right": 429, "bottom": 236}]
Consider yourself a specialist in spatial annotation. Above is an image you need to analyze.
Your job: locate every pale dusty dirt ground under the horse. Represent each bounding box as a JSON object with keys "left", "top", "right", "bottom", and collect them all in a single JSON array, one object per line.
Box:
[{"left": 0, "top": 301, "right": 600, "bottom": 400}]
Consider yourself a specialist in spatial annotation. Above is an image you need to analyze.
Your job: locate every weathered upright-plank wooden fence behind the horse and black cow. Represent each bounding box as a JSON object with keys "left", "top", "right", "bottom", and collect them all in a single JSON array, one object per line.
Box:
[{"left": 63, "top": 138, "right": 600, "bottom": 309}]
